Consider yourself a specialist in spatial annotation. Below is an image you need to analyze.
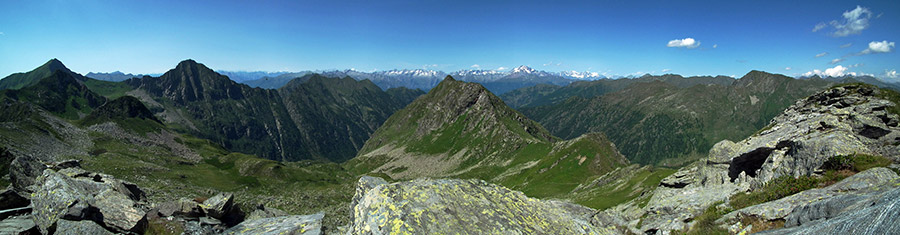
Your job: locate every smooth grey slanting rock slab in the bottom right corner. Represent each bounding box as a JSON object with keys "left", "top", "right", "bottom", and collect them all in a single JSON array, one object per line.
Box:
[{"left": 759, "top": 184, "right": 900, "bottom": 234}]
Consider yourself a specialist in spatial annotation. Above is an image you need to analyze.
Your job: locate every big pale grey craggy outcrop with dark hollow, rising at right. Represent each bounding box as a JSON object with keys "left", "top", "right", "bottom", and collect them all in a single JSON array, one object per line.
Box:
[{"left": 607, "top": 84, "right": 900, "bottom": 234}]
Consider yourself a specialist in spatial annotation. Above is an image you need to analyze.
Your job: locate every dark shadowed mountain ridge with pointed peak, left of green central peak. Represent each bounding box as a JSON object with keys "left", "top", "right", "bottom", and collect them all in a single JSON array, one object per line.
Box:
[{"left": 126, "top": 60, "right": 426, "bottom": 161}]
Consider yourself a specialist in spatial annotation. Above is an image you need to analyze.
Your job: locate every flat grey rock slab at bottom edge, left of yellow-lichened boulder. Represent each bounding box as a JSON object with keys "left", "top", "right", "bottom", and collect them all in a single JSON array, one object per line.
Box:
[{"left": 224, "top": 213, "right": 325, "bottom": 235}]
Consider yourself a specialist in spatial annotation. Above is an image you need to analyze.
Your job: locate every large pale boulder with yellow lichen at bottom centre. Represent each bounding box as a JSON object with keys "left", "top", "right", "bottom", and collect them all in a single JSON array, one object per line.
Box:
[{"left": 349, "top": 179, "right": 618, "bottom": 234}]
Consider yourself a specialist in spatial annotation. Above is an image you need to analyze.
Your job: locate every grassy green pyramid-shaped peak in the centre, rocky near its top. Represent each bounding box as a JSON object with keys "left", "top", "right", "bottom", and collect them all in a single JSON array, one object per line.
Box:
[{"left": 348, "top": 76, "right": 628, "bottom": 196}]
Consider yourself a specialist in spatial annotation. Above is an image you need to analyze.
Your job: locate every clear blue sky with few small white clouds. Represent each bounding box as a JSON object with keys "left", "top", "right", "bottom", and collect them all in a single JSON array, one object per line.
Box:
[{"left": 0, "top": 0, "right": 900, "bottom": 81}]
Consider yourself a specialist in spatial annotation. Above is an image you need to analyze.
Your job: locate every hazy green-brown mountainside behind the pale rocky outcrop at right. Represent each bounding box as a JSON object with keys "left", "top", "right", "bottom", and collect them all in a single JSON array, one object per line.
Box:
[{"left": 522, "top": 71, "right": 833, "bottom": 164}]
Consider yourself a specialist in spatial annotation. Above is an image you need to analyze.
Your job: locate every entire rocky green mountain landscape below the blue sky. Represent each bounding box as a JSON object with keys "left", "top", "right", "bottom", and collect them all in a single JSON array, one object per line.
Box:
[{"left": 0, "top": 59, "right": 900, "bottom": 234}]
